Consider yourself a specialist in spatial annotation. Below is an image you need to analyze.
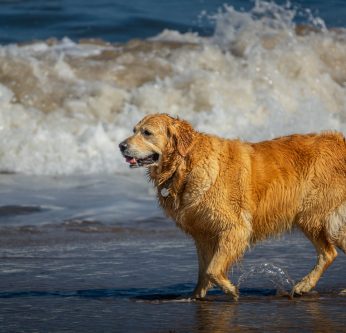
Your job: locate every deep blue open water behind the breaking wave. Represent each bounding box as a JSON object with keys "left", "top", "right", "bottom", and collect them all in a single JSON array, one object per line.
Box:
[{"left": 0, "top": 0, "right": 346, "bottom": 44}]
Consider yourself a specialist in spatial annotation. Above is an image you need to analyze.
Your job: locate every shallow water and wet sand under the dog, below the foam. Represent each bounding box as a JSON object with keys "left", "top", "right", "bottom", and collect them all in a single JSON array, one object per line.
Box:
[{"left": 0, "top": 170, "right": 346, "bottom": 332}]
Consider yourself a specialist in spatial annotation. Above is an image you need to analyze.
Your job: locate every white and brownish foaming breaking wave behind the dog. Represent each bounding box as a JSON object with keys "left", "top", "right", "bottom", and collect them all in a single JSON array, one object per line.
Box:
[{"left": 0, "top": 1, "right": 346, "bottom": 174}]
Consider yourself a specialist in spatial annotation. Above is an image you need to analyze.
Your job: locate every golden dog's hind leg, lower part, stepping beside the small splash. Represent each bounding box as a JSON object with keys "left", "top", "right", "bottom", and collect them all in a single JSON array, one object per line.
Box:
[{"left": 293, "top": 231, "right": 337, "bottom": 295}]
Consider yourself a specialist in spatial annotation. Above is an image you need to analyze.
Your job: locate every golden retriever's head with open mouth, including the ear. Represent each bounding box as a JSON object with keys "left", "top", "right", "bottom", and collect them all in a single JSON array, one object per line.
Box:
[{"left": 119, "top": 114, "right": 195, "bottom": 167}]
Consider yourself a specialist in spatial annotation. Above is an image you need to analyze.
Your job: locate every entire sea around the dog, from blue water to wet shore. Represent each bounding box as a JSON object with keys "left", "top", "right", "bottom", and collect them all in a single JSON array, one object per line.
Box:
[{"left": 0, "top": 0, "right": 346, "bottom": 333}]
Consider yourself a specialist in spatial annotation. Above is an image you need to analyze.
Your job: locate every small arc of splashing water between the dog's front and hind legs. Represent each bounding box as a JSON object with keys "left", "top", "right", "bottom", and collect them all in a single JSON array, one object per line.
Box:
[{"left": 237, "top": 263, "right": 294, "bottom": 295}]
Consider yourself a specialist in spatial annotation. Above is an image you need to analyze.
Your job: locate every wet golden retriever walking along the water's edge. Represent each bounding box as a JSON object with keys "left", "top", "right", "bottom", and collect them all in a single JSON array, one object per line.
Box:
[{"left": 119, "top": 114, "right": 346, "bottom": 300}]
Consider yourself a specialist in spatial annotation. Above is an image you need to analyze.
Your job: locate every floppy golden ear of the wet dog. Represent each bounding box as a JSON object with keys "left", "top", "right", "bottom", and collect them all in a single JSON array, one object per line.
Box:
[{"left": 167, "top": 119, "right": 195, "bottom": 157}]
